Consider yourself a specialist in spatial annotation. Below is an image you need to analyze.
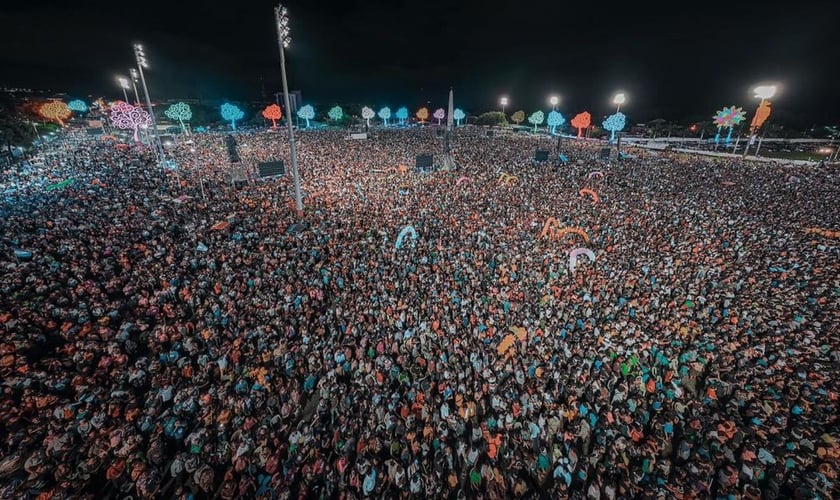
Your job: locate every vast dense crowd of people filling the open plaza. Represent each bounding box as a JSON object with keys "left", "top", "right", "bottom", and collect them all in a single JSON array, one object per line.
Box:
[{"left": 0, "top": 128, "right": 840, "bottom": 499}]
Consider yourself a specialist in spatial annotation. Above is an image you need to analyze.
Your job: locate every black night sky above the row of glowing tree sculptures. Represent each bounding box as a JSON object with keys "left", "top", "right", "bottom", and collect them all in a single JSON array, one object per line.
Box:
[{"left": 0, "top": 0, "right": 840, "bottom": 126}]
